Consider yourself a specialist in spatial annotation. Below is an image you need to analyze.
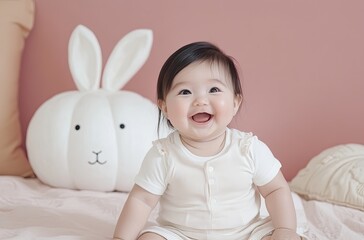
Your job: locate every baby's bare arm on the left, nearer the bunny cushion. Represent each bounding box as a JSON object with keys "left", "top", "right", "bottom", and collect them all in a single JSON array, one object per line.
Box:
[{"left": 114, "top": 185, "right": 160, "bottom": 240}]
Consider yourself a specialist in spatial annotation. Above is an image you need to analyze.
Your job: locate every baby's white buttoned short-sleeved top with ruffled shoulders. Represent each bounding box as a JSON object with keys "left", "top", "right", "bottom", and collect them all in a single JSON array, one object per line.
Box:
[{"left": 136, "top": 129, "right": 281, "bottom": 237}]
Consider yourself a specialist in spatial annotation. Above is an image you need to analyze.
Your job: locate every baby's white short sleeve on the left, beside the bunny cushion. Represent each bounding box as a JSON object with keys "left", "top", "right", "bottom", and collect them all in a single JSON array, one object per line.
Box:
[{"left": 135, "top": 142, "right": 169, "bottom": 195}]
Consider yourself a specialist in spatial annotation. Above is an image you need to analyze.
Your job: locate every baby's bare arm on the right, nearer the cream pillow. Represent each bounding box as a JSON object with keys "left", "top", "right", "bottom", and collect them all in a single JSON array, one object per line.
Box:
[{"left": 258, "top": 171, "right": 300, "bottom": 240}]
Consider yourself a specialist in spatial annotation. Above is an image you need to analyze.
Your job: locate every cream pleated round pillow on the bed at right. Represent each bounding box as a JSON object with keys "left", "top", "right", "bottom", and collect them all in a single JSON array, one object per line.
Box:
[{"left": 290, "top": 144, "right": 364, "bottom": 211}]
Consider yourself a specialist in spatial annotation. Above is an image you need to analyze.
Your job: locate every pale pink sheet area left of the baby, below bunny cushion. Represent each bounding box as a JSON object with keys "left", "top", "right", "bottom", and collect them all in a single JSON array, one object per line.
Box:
[{"left": 0, "top": 177, "right": 127, "bottom": 240}]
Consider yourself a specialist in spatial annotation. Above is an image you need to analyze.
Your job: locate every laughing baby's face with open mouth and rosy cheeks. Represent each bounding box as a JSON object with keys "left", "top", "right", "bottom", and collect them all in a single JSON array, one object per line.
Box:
[{"left": 161, "top": 62, "right": 241, "bottom": 141}]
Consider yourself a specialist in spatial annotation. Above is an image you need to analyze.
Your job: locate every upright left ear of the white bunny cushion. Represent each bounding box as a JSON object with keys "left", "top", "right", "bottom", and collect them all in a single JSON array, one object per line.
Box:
[{"left": 68, "top": 25, "right": 102, "bottom": 91}]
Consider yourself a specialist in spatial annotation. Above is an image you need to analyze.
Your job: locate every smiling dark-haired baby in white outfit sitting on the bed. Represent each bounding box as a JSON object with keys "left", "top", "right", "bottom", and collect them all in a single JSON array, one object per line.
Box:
[{"left": 114, "top": 42, "right": 301, "bottom": 240}]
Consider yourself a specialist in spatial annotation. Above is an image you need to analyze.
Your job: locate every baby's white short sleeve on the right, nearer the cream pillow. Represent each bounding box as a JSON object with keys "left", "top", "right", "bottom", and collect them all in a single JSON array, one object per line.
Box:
[{"left": 250, "top": 137, "right": 282, "bottom": 186}]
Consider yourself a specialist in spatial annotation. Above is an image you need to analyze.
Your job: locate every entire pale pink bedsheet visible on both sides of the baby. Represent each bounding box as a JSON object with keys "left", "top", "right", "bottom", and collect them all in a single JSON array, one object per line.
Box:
[{"left": 0, "top": 176, "right": 364, "bottom": 240}]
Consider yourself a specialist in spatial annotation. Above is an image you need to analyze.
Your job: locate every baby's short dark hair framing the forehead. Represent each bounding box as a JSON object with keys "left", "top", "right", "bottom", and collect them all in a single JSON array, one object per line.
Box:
[{"left": 157, "top": 42, "right": 243, "bottom": 129}]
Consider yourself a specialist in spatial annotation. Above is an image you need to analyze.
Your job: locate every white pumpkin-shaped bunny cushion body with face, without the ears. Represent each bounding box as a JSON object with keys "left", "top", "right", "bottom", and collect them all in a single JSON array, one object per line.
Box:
[{"left": 27, "top": 88, "right": 158, "bottom": 191}]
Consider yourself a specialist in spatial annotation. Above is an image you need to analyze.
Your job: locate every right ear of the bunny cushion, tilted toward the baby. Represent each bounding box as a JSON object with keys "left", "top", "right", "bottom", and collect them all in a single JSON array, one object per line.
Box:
[{"left": 102, "top": 29, "right": 153, "bottom": 91}]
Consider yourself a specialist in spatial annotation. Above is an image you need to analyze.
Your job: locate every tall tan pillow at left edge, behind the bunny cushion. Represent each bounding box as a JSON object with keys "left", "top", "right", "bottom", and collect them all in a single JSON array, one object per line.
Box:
[{"left": 0, "top": 0, "right": 34, "bottom": 177}]
